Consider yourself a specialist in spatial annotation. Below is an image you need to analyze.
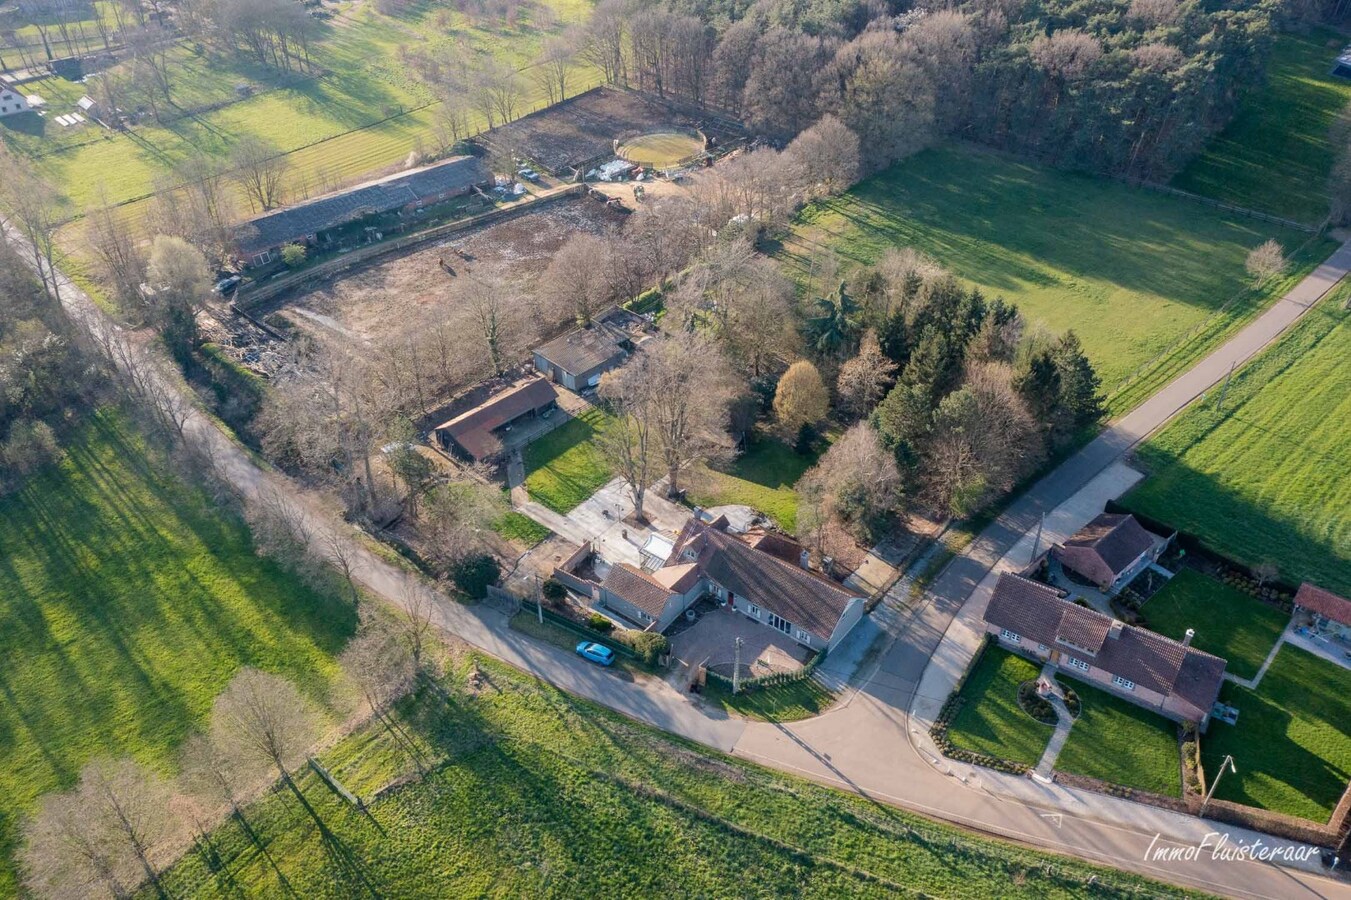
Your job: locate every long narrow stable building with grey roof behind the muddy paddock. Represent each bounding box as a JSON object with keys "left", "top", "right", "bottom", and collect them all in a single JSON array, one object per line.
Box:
[{"left": 235, "top": 157, "right": 493, "bottom": 266}]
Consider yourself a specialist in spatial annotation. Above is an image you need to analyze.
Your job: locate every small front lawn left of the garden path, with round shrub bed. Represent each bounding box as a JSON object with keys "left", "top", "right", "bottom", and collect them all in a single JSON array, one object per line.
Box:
[{"left": 947, "top": 645, "right": 1055, "bottom": 766}]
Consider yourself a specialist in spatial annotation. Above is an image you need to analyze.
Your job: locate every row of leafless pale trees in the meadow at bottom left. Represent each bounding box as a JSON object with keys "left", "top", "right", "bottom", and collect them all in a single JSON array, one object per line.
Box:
[{"left": 20, "top": 595, "right": 432, "bottom": 900}]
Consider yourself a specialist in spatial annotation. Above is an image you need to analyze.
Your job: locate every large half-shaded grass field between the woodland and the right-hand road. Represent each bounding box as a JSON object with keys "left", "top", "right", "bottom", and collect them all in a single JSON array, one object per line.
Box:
[{"left": 781, "top": 146, "right": 1335, "bottom": 402}]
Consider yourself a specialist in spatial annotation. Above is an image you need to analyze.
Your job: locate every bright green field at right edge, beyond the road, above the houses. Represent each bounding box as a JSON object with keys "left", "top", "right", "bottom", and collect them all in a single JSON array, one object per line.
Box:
[{"left": 1123, "top": 286, "right": 1351, "bottom": 595}]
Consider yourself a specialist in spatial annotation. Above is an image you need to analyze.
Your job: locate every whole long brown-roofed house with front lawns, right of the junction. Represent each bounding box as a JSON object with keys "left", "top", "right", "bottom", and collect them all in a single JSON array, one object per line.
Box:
[{"left": 985, "top": 573, "right": 1225, "bottom": 731}]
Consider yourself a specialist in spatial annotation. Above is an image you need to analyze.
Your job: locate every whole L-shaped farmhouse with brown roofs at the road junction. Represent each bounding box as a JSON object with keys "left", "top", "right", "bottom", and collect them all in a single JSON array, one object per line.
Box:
[{"left": 594, "top": 519, "right": 865, "bottom": 651}]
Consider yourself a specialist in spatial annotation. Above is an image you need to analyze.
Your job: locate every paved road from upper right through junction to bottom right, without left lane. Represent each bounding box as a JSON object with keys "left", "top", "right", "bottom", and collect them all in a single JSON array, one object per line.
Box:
[{"left": 734, "top": 242, "right": 1351, "bottom": 897}]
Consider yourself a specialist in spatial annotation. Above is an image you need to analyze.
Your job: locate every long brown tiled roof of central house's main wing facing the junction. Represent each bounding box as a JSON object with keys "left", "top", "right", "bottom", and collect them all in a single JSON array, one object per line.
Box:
[{"left": 666, "top": 519, "right": 855, "bottom": 641}]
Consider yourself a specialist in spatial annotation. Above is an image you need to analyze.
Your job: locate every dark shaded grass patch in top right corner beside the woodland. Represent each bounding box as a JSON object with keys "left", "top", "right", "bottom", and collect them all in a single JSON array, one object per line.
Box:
[{"left": 1173, "top": 28, "right": 1351, "bottom": 224}]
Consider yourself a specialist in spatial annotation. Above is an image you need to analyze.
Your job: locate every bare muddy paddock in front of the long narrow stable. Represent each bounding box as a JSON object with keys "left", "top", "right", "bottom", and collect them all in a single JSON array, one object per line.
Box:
[{"left": 274, "top": 197, "right": 626, "bottom": 342}]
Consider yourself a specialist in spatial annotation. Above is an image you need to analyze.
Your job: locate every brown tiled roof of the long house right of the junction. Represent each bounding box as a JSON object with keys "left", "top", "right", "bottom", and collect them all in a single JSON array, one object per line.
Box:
[{"left": 985, "top": 574, "right": 1225, "bottom": 720}]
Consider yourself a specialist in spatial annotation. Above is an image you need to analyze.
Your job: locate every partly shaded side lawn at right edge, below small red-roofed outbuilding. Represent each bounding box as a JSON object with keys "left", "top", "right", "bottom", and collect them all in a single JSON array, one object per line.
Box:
[{"left": 1201, "top": 645, "right": 1351, "bottom": 822}]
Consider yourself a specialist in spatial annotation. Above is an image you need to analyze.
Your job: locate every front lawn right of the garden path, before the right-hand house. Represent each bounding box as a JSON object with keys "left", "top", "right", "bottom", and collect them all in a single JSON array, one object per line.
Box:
[{"left": 1055, "top": 673, "right": 1183, "bottom": 797}]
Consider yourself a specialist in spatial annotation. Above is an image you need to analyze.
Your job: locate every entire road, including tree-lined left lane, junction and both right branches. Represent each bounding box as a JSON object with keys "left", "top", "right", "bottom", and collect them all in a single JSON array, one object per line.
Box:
[{"left": 15, "top": 212, "right": 1351, "bottom": 897}]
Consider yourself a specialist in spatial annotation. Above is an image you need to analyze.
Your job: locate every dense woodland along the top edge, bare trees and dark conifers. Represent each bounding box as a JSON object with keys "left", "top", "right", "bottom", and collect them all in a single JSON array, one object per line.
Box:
[{"left": 581, "top": 0, "right": 1278, "bottom": 177}]
